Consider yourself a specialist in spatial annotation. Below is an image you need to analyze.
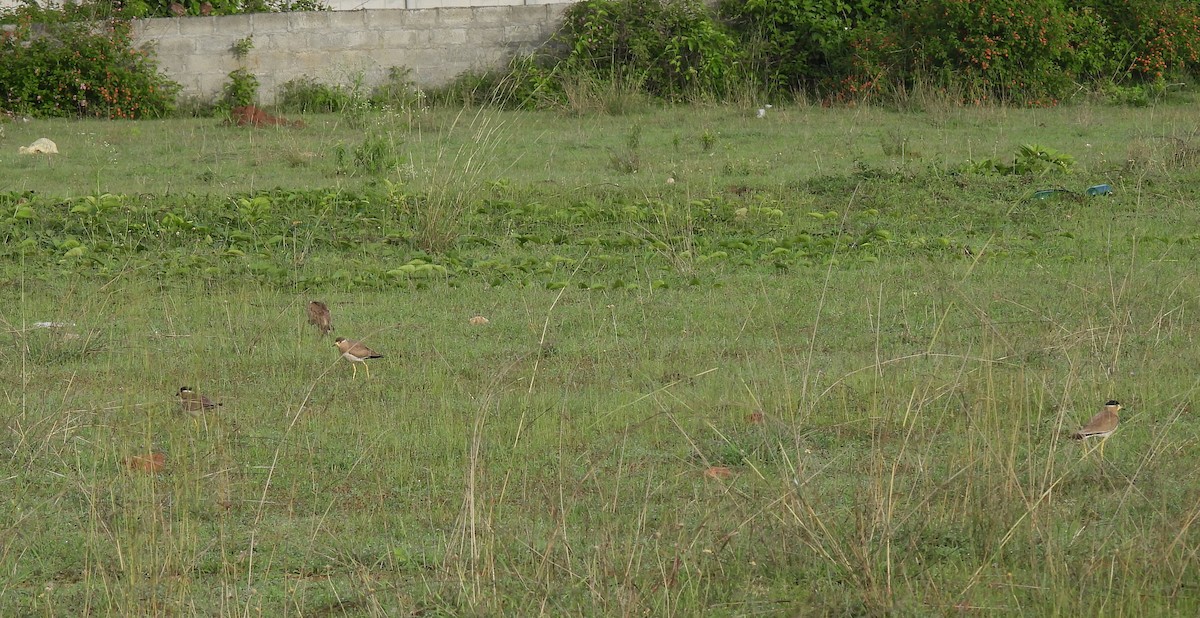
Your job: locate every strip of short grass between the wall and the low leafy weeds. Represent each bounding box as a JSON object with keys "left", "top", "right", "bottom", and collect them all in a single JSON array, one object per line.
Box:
[{"left": 0, "top": 106, "right": 1198, "bottom": 197}]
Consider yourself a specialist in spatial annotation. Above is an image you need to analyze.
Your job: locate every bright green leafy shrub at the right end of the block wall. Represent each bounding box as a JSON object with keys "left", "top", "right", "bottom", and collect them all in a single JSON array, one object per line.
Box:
[{"left": 557, "top": 0, "right": 740, "bottom": 98}]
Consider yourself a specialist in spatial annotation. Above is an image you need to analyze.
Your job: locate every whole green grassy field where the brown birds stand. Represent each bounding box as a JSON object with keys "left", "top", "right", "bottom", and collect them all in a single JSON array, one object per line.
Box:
[{"left": 0, "top": 101, "right": 1200, "bottom": 616}]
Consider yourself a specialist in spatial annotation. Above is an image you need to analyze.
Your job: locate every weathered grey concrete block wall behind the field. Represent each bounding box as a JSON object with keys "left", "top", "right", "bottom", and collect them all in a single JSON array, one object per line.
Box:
[{"left": 133, "top": 0, "right": 570, "bottom": 104}]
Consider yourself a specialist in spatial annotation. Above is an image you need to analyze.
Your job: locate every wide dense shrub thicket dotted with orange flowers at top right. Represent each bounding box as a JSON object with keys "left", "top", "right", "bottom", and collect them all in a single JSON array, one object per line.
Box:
[{"left": 720, "top": 0, "right": 1200, "bottom": 104}]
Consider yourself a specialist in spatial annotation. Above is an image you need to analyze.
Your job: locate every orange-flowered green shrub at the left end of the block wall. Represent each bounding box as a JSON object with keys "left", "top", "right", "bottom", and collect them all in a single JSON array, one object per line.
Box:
[{"left": 0, "top": 5, "right": 179, "bottom": 119}]
